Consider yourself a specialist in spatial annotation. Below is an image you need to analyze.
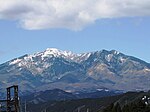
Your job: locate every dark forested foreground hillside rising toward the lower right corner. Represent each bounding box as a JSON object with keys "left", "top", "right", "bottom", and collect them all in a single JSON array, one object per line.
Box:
[{"left": 27, "top": 92, "right": 150, "bottom": 112}]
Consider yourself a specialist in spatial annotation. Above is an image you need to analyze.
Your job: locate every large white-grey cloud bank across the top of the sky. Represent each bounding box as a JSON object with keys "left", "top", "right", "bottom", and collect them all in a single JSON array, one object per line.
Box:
[{"left": 0, "top": 0, "right": 150, "bottom": 30}]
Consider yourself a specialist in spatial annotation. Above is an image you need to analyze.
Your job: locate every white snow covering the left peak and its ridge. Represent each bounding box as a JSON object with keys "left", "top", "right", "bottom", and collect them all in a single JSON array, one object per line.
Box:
[{"left": 9, "top": 48, "right": 92, "bottom": 66}]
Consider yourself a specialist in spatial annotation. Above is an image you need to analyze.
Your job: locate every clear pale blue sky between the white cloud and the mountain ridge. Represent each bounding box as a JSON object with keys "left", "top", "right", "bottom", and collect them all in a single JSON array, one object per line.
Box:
[{"left": 0, "top": 17, "right": 150, "bottom": 63}]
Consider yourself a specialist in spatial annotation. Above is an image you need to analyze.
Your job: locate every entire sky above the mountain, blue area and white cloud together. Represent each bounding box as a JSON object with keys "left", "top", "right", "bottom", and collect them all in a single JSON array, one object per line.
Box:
[{"left": 0, "top": 0, "right": 150, "bottom": 63}]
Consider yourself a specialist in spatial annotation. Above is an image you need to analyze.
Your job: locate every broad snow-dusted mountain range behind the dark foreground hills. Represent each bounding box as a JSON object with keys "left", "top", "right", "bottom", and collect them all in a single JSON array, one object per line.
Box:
[{"left": 0, "top": 48, "right": 150, "bottom": 95}]
